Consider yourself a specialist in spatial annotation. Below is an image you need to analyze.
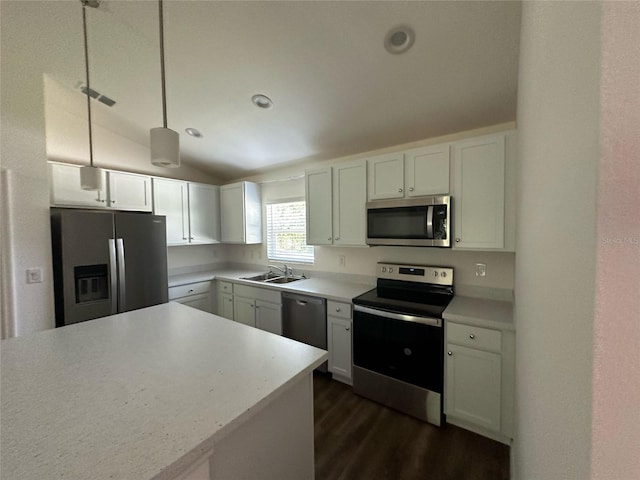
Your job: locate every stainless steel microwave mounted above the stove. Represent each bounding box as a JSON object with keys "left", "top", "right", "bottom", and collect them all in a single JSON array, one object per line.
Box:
[{"left": 367, "top": 195, "right": 451, "bottom": 247}]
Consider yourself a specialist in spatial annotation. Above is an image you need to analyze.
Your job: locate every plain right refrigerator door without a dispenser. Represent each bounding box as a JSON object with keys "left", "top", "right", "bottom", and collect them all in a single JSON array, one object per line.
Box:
[{"left": 115, "top": 212, "right": 169, "bottom": 312}]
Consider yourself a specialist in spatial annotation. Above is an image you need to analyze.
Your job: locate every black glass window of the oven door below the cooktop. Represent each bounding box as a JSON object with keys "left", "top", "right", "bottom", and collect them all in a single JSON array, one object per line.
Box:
[{"left": 353, "top": 312, "right": 444, "bottom": 393}]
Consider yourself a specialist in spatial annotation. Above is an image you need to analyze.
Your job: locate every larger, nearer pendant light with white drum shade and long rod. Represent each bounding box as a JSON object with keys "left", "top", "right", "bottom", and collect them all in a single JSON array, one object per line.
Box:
[{"left": 149, "top": 0, "right": 180, "bottom": 168}]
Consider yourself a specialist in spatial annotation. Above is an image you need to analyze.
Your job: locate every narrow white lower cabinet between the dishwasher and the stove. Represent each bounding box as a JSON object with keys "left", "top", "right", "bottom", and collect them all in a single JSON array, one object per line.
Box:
[{"left": 327, "top": 300, "right": 352, "bottom": 385}]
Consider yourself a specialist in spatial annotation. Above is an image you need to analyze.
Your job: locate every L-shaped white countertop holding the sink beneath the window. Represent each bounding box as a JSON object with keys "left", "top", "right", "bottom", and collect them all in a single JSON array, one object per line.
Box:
[{"left": 169, "top": 268, "right": 375, "bottom": 302}]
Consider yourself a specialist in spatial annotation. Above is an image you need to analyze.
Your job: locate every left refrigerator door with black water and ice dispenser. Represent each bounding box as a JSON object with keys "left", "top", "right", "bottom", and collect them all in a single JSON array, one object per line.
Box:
[{"left": 51, "top": 208, "right": 117, "bottom": 327}]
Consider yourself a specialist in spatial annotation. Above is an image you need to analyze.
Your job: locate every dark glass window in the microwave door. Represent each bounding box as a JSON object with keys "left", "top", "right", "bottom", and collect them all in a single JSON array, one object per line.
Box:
[{"left": 367, "top": 206, "right": 427, "bottom": 238}]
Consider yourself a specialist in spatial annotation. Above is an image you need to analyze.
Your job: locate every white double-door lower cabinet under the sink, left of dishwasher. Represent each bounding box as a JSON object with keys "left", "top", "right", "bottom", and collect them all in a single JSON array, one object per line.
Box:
[{"left": 228, "top": 284, "right": 282, "bottom": 335}]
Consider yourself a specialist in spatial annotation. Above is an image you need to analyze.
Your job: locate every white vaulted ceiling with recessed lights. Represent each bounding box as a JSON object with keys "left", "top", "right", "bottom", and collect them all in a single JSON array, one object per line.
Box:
[{"left": 11, "top": 0, "right": 520, "bottom": 179}]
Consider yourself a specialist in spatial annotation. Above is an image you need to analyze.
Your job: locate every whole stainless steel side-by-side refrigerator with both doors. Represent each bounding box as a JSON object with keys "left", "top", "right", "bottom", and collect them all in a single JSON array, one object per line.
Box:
[{"left": 51, "top": 208, "right": 168, "bottom": 327}]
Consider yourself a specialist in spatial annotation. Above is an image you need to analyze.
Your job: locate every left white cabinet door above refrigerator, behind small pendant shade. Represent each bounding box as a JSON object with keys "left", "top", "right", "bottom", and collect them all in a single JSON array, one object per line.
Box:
[{"left": 49, "top": 163, "right": 107, "bottom": 208}]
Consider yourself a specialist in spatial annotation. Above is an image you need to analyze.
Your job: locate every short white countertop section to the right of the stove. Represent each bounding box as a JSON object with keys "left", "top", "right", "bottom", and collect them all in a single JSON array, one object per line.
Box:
[{"left": 443, "top": 295, "right": 515, "bottom": 331}]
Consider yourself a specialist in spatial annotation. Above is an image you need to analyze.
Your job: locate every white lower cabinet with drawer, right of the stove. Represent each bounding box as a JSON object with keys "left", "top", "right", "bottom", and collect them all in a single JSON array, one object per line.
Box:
[{"left": 444, "top": 321, "right": 514, "bottom": 444}]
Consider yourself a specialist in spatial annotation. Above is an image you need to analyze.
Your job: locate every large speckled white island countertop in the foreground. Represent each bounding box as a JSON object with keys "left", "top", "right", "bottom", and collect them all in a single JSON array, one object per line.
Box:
[{"left": 1, "top": 303, "right": 327, "bottom": 480}]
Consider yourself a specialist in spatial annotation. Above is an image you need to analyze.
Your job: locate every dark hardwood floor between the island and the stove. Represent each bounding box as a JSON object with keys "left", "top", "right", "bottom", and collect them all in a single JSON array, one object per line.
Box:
[{"left": 314, "top": 373, "right": 509, "bottom": 480}]
